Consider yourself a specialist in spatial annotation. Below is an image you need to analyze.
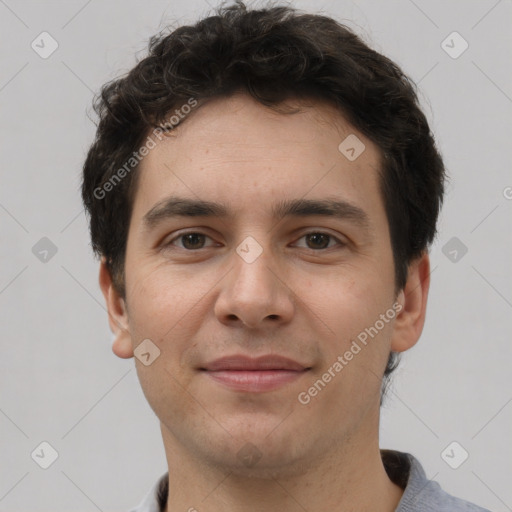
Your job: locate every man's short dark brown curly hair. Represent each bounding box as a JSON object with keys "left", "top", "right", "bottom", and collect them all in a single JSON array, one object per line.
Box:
[{"left": 82, "top": 0, "right": 445, "bottom": 396}]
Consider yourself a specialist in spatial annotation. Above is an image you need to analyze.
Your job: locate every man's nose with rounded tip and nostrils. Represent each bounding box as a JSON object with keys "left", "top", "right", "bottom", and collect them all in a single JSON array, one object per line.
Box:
[{"left": 214, "top": 245, "right": 295, "bottom": 329}]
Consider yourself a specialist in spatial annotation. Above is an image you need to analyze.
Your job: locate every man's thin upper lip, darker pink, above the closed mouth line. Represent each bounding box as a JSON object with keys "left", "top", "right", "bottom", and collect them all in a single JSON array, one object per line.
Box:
[{"left": 201, "top": 354, "right": 309, "bottom": 372}]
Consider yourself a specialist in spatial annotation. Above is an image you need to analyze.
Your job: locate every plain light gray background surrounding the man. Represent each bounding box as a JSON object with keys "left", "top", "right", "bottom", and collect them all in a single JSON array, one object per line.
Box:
[{"left": 0, "top": 0, "right": 512, "bottom": 512}]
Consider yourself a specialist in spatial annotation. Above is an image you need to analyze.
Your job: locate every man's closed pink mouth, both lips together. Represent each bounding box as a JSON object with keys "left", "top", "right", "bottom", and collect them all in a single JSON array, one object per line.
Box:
[{"left": 200, "top": 355, "right": 311, "bottom": 393}]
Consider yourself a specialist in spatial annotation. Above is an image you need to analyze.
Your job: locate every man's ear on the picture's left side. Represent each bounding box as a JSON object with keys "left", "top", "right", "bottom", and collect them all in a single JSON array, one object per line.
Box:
[{"left": 99, "top": 257, "right": 133, "bottom": 359}]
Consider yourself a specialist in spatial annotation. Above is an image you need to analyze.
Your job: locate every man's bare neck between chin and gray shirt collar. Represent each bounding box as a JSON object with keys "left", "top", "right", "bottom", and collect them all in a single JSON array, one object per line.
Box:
[{"left": 162, "top": 414, "right": 403, "bottom": 512}]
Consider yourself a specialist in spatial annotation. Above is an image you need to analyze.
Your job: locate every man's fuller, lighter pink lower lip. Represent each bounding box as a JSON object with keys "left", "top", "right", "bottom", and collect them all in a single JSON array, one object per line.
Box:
[{"left": 206, "top": 370, "right": 307, "bottom": 393}]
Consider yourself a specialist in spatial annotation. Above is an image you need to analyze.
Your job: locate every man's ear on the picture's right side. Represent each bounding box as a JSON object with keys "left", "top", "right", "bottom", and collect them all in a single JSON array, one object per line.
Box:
[{"left": 391, "top": 252, "right": 430, "bottom": 352}]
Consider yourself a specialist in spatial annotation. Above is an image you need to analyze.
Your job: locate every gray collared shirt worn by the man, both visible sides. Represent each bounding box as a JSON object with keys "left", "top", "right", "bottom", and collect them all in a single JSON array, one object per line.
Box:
[{"left": 130, "top": 450, "right": 490, "bottom": 512}]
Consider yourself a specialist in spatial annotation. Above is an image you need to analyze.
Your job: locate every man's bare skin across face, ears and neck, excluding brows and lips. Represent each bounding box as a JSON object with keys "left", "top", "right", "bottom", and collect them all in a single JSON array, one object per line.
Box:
[{"left": 100, "top": 94, "right": 429, "bottom": 512}]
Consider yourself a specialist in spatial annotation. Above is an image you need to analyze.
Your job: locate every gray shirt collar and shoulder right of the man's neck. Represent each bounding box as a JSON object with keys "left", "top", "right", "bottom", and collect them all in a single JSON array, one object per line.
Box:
[{"left": 382, "top": 450, "right": 490, "bottom": 512}]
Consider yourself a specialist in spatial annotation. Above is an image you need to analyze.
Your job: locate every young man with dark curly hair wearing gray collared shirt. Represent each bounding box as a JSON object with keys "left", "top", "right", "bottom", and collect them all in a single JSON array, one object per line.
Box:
[{"left": 82, "top": 2, "right": 490, "bottom": 512}]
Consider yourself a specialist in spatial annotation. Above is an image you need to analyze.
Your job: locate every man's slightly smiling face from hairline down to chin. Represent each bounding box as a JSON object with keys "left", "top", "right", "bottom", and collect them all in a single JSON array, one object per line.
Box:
[{"left": 102, "top": 94, "right": 424, "bottom": 472}]
